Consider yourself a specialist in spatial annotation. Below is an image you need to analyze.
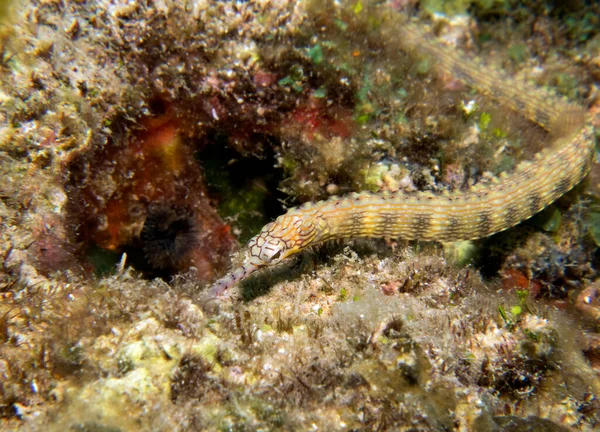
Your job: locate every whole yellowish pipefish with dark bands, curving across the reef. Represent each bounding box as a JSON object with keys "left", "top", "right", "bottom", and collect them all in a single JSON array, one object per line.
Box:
[{"left": 210, "top": 23, "right": 595, "bottom": 296}]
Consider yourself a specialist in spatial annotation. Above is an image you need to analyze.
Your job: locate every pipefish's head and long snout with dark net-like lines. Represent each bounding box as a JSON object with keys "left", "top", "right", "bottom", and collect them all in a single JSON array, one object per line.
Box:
[{"left": 210, "top": 211, "right": 317, "bottom": 296}]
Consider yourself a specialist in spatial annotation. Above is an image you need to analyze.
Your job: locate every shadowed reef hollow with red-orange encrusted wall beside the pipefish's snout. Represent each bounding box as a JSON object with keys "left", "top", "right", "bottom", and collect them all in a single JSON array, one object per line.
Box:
[{"left": 65, "top": 103, "right": 283, "bottom": 283}]
